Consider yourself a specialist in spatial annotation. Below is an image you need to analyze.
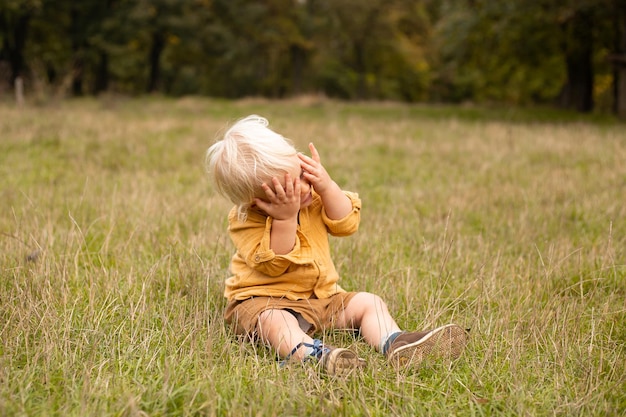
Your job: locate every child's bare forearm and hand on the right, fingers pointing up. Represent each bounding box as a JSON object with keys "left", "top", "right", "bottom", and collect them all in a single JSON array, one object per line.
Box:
[{"left": 298, "top": 143, "right": 352, "bottom": 220}]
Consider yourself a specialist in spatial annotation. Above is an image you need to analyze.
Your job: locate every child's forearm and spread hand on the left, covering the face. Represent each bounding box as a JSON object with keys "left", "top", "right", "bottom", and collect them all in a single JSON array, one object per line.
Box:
[{"left": 255, "top": 174, "right": 300, "bottom": 255}]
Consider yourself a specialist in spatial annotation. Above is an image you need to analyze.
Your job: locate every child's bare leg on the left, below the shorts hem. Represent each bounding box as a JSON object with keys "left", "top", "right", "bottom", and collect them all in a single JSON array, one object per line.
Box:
[{"left": 258, "top": 310, "right": 313, "bottom": 359}]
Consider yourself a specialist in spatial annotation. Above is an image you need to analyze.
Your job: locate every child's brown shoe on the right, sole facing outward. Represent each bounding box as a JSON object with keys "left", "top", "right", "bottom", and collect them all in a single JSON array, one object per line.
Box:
[{"left": 387, "top": 324, "right": 468, "bottom": 367}]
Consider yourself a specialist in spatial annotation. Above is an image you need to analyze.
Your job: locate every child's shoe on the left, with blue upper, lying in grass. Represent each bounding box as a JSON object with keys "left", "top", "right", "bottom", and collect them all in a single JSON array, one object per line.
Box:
[{"left": 283, "top": 339, "right": 365, "bottom": 376}]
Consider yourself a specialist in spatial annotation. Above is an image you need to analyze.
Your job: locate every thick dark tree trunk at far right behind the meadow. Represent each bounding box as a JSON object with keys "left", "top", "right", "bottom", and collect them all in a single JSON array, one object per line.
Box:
[{"left": 561, "top": 10, "right": 593, "bottom": 112}]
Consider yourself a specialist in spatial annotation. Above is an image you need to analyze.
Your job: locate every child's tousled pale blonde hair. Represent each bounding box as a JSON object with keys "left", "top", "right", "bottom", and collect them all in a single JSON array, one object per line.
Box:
[{"left": 206, "top": 115, "right": 297, "bottom": 221}]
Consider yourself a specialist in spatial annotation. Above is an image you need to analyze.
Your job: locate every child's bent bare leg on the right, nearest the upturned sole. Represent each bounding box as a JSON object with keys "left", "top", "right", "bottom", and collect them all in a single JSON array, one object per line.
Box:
[{"left": 336, "top": 292, "right": 400, "bottom": 350}]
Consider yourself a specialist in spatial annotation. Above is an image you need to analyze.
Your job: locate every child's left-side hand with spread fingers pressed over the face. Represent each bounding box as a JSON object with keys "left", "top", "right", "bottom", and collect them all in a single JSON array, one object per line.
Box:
[{"left": 254, "top": 174, "right": 300, "bottom": 220}]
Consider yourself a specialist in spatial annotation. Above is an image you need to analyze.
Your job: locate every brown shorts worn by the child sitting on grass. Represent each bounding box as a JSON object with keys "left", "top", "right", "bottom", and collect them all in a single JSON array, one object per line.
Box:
[{"left": 224, "top": 292, "right": 357, "bottom": 338}]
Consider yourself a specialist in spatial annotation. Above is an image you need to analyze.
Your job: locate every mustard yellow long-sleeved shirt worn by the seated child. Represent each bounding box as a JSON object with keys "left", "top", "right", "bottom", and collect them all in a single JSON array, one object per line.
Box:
[{"left": 224, "top": 191, "right": 361, "bottom": 301}]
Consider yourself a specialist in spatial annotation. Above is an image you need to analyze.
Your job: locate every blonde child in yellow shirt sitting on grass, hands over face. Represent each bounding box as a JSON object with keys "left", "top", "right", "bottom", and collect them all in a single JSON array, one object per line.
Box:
[{"left": 207, "top": 115, "right": 467, "bottom": 375}]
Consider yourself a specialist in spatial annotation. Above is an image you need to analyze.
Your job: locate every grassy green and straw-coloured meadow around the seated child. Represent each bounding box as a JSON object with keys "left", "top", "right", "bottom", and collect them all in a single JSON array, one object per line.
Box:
[{"left": 0, "top": 98, "right": 626, "bottom": 416}]
